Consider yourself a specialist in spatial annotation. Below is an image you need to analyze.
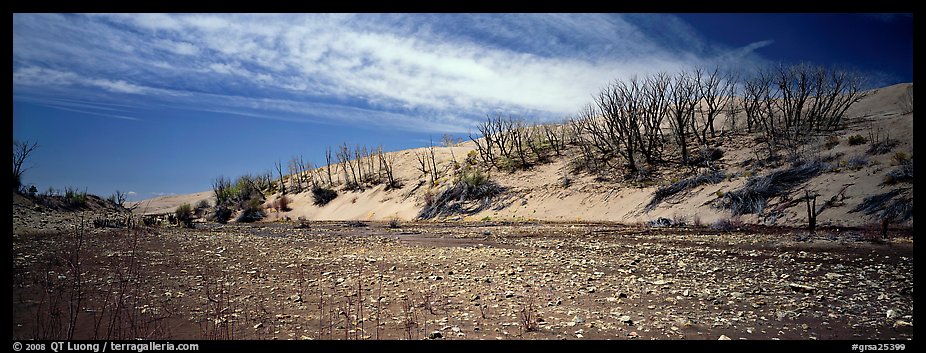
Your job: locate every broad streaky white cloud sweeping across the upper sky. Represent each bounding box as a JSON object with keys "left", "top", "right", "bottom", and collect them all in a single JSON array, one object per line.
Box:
[{"left": 13, "top": 14, "right": 770, "bottom": 132}]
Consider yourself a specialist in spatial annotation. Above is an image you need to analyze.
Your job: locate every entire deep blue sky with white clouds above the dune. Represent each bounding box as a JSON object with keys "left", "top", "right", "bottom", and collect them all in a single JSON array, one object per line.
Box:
[{"left": 13, "top": 14, "right": 913, "bottom": 199}]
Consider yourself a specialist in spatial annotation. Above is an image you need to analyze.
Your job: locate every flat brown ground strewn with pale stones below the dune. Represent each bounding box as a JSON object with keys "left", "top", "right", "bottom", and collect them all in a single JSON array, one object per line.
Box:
[{"left": 12, "top": 205, "right": 913, "bottom": 340}]
